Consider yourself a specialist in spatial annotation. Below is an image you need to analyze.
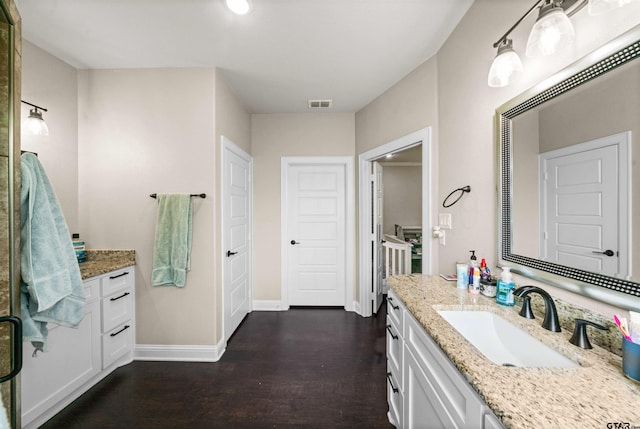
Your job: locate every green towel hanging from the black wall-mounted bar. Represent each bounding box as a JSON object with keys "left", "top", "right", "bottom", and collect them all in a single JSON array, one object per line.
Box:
[{"left": 151, "top": 194, "right": 192, "bottom": 287}]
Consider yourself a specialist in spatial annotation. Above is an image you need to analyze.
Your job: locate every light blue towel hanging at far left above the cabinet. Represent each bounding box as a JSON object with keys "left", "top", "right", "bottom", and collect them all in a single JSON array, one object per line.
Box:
[{"left": 20, "top": 153, "right": 85, "bottom": 350}]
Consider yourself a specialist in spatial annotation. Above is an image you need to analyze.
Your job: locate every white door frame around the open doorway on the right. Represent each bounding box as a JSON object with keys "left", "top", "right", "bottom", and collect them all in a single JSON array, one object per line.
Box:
[{"left": 358, "top": 127, "right": 432, "bottom": 317}]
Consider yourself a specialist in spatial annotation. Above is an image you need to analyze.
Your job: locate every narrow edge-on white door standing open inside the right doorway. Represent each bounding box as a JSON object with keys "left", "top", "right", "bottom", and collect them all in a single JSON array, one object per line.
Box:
[{"left": 371, "top": 162, "right": 385, "bottom": 313}]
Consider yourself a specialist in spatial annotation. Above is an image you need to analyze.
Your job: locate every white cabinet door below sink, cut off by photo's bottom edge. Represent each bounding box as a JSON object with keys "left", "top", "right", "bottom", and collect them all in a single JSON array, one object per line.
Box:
[{"left": 403, "top": 344, "right": 459, "bottom": 429}]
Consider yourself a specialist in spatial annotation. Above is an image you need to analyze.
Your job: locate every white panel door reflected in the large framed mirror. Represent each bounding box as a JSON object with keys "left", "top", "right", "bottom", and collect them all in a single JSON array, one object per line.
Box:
[{"left": 541, "top": 140, "right": 619, "bottom": 276}]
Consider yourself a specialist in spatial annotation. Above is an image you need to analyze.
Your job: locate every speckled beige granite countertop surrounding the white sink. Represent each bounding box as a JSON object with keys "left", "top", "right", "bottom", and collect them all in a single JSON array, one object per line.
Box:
[{"left": 389, "top": 275, "right": 640, "bottom": 429}]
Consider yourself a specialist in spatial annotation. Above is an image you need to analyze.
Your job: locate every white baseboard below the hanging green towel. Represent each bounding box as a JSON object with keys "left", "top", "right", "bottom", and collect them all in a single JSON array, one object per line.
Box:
[{"left": 134, "top": 339, "right": 227, "bottom": 362}]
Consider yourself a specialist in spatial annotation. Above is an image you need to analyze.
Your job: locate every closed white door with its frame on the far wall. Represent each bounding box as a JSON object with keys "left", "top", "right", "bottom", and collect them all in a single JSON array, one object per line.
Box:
[{"left": 281, "top": 157, "right": 353, "bottom": 310}]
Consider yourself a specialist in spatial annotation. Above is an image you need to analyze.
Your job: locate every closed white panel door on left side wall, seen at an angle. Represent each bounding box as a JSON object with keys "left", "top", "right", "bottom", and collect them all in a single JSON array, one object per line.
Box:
[{"left": 222, "top": 137, "right": 252, "bottom": 340}]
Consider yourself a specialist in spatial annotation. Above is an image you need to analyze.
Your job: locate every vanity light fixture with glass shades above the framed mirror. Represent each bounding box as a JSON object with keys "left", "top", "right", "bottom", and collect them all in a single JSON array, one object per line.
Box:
[{"left": 488, "top": 0, "right": 637, "bottom": 88}]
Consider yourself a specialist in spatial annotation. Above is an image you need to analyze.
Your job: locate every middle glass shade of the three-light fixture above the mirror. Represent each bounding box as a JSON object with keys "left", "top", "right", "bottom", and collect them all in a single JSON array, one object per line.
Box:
[{"left": 527, "top": 7, "right": 575, "bottom": 57}]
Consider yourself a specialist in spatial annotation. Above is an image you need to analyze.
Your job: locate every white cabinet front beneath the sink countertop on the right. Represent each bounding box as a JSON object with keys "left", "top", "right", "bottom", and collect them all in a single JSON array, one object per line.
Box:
[{"left": 387, "top": 291, "right": 502, "bottom": 429}]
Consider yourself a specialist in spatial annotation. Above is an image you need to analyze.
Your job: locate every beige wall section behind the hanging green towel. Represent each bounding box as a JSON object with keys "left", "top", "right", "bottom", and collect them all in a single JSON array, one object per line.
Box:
[{"left": 79, "top": 69, "right": 217, "bottom": 345}]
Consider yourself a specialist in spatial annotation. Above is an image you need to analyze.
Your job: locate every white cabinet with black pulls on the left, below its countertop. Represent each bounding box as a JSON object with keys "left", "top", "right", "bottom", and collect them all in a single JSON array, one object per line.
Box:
[{"left": 20, "top": 266, "right": 135, "bottom": 428}]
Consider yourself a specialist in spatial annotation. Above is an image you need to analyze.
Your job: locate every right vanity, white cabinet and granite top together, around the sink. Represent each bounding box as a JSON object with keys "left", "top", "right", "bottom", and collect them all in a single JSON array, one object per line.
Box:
[{"left": 387, "top": 275, "right": 640, "bottom": 429}]
